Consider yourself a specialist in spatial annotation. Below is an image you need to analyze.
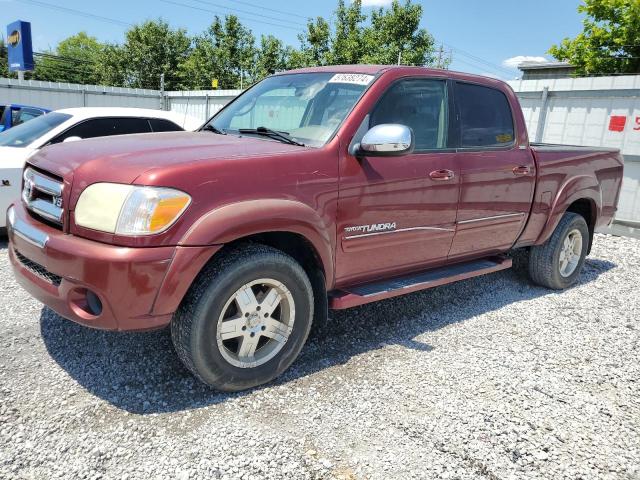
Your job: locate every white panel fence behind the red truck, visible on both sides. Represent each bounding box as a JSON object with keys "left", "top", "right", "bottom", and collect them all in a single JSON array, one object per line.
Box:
[{"left": 0, "top": 75, "right": 640, "bottom": 225}]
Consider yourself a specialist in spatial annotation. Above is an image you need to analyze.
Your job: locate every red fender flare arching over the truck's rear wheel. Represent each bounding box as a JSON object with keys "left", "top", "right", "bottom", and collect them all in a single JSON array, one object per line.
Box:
[{"left": 535, "top": 175, "right": 602, "bottom": 245}]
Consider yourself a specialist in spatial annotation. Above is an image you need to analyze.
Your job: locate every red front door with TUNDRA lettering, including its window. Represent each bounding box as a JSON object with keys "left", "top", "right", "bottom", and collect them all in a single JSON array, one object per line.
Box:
[{"left": 336, "top": 78, "right": 459, "bottom": 287}]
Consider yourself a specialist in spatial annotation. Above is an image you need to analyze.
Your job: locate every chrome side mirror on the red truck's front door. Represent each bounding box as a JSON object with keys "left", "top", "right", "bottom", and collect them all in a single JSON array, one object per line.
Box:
[{"left": 357, "top": 123, "right": 415, "bottom": 157}]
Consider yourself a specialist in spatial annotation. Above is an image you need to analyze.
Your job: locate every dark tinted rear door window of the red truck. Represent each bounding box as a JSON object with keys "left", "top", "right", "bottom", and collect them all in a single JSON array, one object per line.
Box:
[{"left": 455, "top": 83, "right": 515, "bottom": 148}]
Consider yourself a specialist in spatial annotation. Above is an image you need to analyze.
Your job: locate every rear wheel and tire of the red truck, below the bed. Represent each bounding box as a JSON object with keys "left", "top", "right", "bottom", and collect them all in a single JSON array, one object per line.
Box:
[{"left": 529, "top": 212, "right": 590, "bottom": 290}]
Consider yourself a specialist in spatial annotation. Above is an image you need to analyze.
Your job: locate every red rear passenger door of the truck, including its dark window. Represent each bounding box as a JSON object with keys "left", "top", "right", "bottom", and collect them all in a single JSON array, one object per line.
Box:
[{"left": 449, "top": 82, "right": 536, "bottom": 259}]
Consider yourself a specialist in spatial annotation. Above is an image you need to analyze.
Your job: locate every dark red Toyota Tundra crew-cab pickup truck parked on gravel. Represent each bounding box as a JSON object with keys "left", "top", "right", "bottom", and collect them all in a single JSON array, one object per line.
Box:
[{"left": 7, "top": 66, "right": 623, "bottom": 390}]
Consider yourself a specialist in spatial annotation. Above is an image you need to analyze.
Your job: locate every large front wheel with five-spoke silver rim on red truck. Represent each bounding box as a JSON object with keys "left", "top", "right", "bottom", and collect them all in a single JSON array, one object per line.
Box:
[{"left": 171, "top": 244, "right": 314, "bottom": 391}]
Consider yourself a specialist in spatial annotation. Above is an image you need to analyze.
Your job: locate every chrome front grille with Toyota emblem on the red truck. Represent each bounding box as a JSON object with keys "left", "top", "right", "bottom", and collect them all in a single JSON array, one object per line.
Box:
[{"left": 22, "top": 167, "right": 64, "bottom": 227}]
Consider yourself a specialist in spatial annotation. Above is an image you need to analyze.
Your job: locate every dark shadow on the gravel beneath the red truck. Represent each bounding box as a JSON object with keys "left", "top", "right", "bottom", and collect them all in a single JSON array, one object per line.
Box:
[{"left": 40, "top": 258, "right": 615, "bottom": 414}]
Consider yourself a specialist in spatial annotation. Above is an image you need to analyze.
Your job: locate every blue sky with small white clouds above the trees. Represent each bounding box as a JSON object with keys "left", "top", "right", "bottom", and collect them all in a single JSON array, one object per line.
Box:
[{"left": 0, "top": 0, "right": 582, "bottom": 80}]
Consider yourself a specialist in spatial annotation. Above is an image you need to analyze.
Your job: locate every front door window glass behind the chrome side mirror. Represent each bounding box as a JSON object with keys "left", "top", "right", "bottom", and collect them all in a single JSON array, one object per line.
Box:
[{"left": 369, "top": 79, "right": 448, "bottom": 150}]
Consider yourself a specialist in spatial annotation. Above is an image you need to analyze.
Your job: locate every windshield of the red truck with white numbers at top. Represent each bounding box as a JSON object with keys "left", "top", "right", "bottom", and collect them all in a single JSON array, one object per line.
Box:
[{"left": 203, "top": 73, "right": 374, "bottom": 147}]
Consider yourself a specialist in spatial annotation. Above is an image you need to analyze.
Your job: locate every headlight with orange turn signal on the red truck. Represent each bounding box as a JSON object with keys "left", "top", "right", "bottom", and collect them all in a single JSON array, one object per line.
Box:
[{"left": 75, "top": 183, "right": 191, "bottom": 235}]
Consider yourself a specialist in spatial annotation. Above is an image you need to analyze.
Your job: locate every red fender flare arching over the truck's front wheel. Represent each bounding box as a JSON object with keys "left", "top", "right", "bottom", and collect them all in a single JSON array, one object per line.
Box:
[{"left": 179, "top": 199, "right": 335, "bottom": 283}]
